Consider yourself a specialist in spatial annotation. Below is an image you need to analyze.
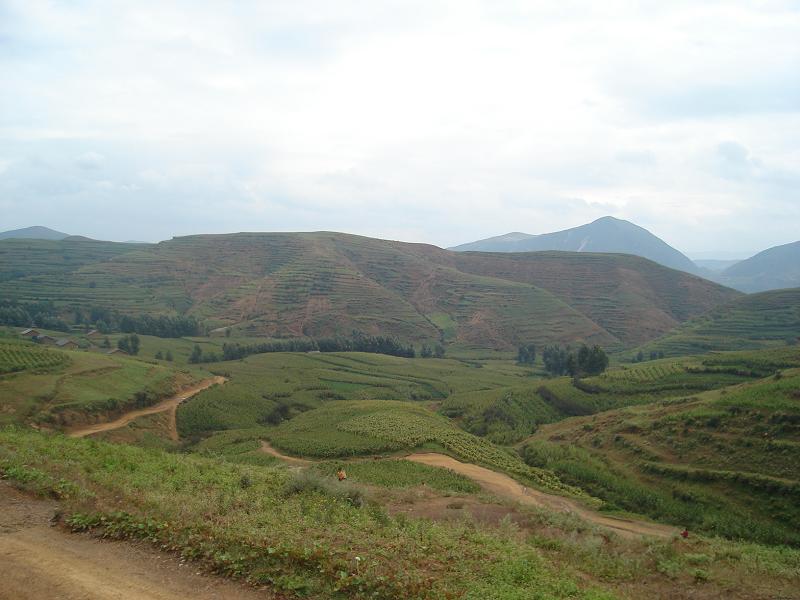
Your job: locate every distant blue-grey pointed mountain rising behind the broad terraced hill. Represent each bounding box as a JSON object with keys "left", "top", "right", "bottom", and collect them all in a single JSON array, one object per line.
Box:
[{"left": 451, "top": 217, "right": 697, "bottom": 273}]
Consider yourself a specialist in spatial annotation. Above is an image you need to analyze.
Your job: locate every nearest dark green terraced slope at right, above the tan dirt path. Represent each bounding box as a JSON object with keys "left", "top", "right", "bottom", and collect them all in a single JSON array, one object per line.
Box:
[{"left": 521, "top": 349, "right": 800, "bottom": 546}]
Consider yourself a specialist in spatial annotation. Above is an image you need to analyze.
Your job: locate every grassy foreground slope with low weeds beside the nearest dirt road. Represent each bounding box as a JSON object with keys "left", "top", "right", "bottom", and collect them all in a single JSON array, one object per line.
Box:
[{"left": 0, "top": 429, "right": 800, "bottom": 600}]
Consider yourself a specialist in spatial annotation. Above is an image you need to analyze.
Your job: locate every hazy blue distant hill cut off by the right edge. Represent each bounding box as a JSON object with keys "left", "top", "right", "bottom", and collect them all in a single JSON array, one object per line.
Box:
[{"left": 718, "top": 241, "right": 800, "bottom": 292}]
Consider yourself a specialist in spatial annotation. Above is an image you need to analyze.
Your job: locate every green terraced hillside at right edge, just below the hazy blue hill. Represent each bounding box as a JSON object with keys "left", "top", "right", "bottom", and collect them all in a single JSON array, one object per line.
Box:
[{"left": 642, "top": 288, "right": 800, "bottom": 356}]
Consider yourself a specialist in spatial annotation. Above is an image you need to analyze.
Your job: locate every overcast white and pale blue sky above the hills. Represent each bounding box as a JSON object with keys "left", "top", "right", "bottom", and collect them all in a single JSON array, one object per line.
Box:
[{"left": 0, "top": 0, "right": 800, "bottom": 256}]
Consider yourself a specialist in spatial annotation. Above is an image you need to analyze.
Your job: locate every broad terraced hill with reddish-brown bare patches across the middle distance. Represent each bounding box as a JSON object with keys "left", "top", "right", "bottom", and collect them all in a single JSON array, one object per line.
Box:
[{"left": 0, "top": 232, "right": 738, "bottom": 349}]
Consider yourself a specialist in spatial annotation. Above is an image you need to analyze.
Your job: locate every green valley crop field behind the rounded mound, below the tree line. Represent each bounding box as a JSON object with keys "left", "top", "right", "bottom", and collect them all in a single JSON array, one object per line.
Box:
[{"left": 178, "top": 352, "right": 528, "bottom": 440}]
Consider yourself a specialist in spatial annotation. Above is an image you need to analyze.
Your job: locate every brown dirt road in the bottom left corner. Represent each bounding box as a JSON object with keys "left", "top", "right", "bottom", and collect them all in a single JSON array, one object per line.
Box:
[{"left": 0, "top": 481, "right": 275, "bottom": 600}]
